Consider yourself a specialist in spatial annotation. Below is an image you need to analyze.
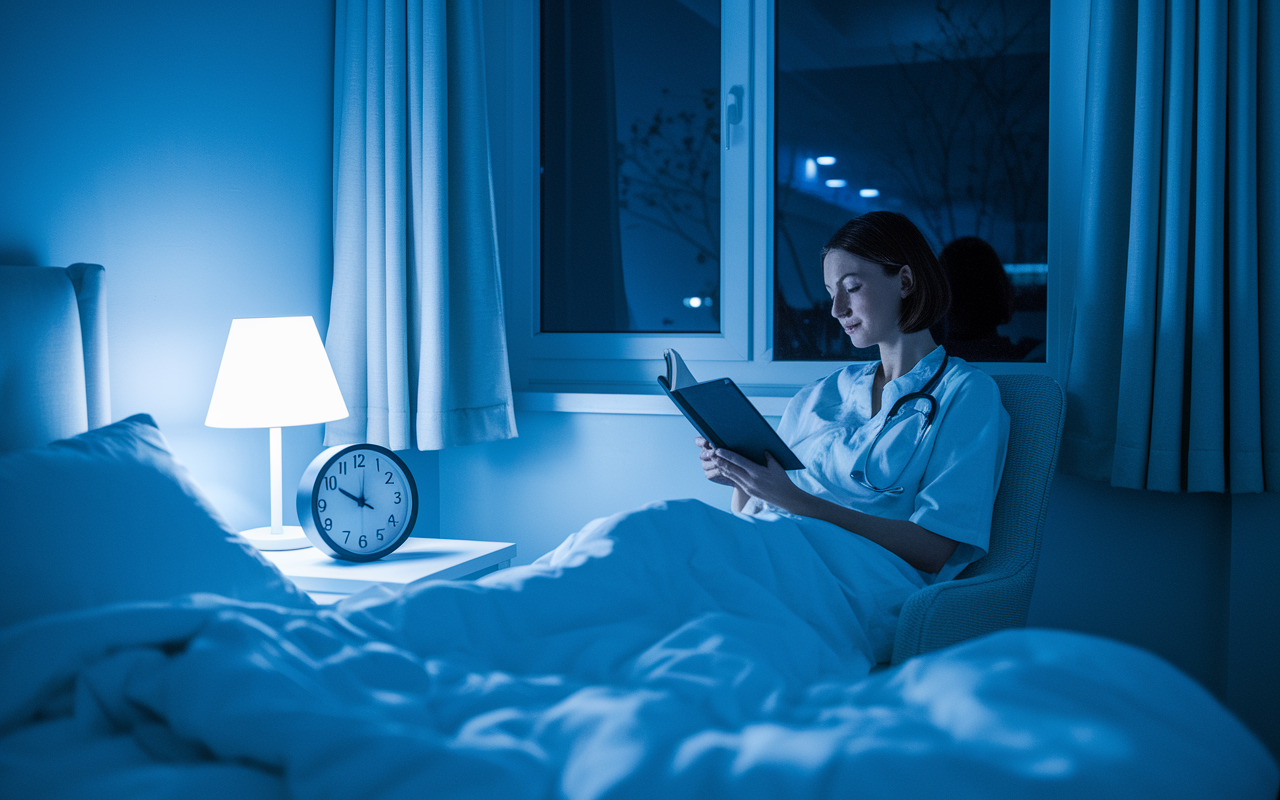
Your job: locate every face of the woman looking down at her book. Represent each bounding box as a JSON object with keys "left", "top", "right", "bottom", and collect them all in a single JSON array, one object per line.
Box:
[{"left": 822, "top": 250, "right": 913, "bottom": 347}]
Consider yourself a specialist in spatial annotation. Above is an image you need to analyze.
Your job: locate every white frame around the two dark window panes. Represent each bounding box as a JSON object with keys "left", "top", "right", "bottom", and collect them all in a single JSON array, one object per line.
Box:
[{"left": 485, "top": 0, "right": 1089, "bottom": 399}]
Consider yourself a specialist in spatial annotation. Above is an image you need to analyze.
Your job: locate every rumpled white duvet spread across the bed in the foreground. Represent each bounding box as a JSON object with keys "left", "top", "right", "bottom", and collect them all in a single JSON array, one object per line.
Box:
[{"left": 0, "top": 502, "right": 1280, "bottom": 800}]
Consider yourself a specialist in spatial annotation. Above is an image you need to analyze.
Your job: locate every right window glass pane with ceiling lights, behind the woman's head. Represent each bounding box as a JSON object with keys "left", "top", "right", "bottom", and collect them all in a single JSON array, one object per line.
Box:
[{"left": 773, "top": 0, "right": 1048, "bottom": 361}]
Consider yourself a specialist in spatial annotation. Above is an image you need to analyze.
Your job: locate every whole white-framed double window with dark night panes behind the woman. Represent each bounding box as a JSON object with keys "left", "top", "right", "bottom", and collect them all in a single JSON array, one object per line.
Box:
[{"left": 486, "top": 0, "right": 1088, "bottom": 396}]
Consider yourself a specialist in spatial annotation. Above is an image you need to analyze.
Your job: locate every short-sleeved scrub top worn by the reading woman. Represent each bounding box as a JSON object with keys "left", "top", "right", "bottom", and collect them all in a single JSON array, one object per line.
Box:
[{"left": 744, "top": 347, "right": 1009, "bottom": 584}]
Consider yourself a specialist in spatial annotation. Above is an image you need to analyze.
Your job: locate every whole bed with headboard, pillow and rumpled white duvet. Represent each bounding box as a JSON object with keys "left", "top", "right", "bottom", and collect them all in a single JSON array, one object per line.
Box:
[{"left": 0, "top": 265, "right": 1280, "bottom": 800}]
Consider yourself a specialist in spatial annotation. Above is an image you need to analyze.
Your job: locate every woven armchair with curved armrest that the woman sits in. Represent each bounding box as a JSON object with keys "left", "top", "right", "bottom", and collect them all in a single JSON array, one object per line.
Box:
[{"left": 892, "top": 375, "right": 1066, "bottom": 664}]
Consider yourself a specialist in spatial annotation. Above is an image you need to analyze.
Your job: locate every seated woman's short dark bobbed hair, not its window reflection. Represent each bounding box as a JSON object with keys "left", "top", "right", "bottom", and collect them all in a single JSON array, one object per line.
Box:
[{"left": 822, "top": 211, "right": 951, "bottom": 333}]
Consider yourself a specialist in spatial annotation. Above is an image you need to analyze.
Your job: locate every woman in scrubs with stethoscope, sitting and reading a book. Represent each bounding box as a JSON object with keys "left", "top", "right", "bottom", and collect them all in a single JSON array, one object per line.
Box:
[{"left": 696, "top": 211, "right": 1009, "bottom": 582}]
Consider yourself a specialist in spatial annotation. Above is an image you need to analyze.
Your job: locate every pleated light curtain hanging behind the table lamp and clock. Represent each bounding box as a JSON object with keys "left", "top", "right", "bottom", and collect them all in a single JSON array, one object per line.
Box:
[{"left": 325, "top": 0, "right": 516, "bottom": 449}]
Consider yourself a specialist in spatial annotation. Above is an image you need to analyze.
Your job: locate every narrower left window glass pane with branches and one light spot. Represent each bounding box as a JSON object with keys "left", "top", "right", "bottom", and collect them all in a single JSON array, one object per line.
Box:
[{"left": 540, "top": 0, "right": 721, "bottom": 333}]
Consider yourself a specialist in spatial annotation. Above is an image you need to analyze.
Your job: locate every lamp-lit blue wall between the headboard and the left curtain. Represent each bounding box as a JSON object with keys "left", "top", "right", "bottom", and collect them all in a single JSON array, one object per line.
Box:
[{"left": 0, "top": 0, "right": 333, "bottom": 527}]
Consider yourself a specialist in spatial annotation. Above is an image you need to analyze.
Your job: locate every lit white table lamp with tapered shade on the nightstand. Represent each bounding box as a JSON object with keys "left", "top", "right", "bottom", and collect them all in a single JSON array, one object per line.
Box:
[{"left": 205, "top": 316, "right": 347, "bottom": 550}]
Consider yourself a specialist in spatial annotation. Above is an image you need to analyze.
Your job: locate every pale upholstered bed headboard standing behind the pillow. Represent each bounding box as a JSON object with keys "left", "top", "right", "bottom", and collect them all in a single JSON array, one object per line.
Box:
[{"left": 0, "top": 264, "right": 111, "bottom": 453}]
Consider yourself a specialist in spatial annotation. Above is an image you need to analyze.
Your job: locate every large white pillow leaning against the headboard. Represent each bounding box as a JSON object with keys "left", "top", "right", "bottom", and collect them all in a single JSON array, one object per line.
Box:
[{"left": 0, "top": 413, "right": 314, "bottom": 627}]
